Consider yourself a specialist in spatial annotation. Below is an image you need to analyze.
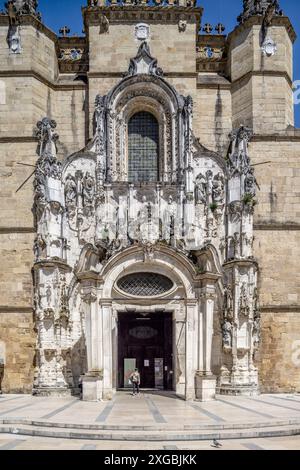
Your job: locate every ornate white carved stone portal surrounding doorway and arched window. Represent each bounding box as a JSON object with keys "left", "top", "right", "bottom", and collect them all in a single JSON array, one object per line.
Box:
[{"left": 34, "top": 42, "right": 260, "bottom": 400}]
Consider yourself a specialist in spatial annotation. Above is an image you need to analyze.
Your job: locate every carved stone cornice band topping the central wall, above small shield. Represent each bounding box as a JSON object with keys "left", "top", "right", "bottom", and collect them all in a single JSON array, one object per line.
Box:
[{"left": 82, "top": 5, "right": 203, "bottom": 27}]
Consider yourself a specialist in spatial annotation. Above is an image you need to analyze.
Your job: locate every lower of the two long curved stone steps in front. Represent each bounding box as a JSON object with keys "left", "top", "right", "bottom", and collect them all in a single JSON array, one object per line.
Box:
[{"left": 0, "top": 424, "right": 300, "bottom": 442}]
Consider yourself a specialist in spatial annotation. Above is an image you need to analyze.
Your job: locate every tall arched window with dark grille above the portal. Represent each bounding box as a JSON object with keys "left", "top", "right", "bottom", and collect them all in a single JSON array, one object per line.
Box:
[{"left": 128, "top": 111, "right": 159, "bottom": 182}]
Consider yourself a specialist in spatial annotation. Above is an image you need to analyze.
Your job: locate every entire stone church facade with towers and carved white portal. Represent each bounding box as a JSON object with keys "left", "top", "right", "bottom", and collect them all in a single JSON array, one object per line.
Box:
[{"left": 0, "top": 0, "right": 300, "bottom": 400}]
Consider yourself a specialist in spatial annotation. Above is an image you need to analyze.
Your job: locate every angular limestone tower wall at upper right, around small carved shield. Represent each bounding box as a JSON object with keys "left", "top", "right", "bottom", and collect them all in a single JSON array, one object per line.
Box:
[{"left": 228, "top": 25, "right": 294, "bottom": 134}]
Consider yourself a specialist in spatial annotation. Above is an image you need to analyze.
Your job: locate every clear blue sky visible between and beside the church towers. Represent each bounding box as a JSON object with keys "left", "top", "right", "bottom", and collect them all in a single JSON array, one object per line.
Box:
[{"left": 0, "top": 0, "right": 300, "bottom": 127}]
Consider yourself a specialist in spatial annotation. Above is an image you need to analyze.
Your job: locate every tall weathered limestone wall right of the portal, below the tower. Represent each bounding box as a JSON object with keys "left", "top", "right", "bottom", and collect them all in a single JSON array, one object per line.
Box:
[{"left": 250, "top": 140, "right": 300, "bottom": 392}]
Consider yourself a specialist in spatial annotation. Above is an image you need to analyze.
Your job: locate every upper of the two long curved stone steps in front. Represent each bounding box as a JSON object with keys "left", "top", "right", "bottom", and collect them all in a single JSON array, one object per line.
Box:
[{"left": 0, "top": 418, "right": 300, "bottom": 432}]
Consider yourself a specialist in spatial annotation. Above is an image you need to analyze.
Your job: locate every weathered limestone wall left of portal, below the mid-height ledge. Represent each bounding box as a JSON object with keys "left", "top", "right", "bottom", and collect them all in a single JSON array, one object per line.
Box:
[{"left": 0, "top": 233, "right": 36, "bottom": 393}]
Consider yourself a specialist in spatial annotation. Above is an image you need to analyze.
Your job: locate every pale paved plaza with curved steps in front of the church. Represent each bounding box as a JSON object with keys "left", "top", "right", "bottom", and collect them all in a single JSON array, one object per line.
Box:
[{"left": 0, "top": 391, "right": 300, "bottom": 450}]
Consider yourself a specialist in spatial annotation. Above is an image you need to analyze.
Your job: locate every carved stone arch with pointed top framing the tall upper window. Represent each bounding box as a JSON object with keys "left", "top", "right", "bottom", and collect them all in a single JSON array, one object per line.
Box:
[{"left": 94, "top": 43, "right": 193, "bottom": 183}]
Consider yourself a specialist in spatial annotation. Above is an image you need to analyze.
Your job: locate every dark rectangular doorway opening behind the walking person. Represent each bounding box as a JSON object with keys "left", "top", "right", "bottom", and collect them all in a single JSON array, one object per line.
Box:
[{"left": 118, "top": 313, "right": 174, "bottom": 390}]
